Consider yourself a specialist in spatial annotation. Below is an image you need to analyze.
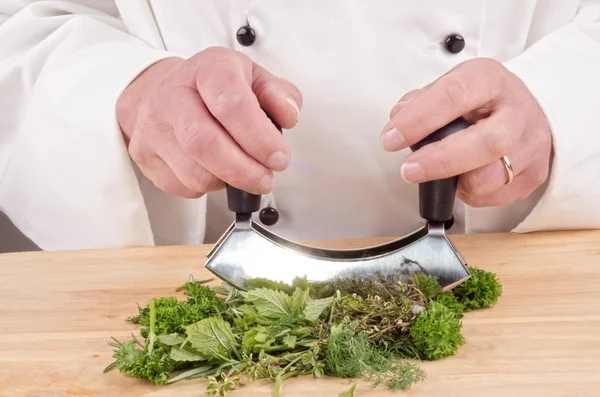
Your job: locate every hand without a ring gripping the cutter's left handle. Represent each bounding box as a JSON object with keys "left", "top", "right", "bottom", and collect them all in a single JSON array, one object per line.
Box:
[{"left": 117, "top": 47, "right": 302, "bottom": 198}]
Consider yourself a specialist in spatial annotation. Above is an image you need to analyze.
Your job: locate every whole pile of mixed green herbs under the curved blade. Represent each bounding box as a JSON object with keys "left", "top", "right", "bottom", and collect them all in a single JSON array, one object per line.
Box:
[{"left": 105, "top": 262, "right": 501, "bottom": 397}]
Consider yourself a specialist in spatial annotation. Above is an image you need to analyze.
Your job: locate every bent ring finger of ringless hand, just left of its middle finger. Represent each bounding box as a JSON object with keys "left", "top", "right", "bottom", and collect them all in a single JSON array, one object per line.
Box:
[{"left": 157, "top": 128, "right": 225, "bottom": 194}]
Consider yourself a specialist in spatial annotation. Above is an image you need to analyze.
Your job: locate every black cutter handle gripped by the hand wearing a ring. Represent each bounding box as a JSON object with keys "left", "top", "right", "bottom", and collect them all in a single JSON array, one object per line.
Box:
[{"left": 410, "top": 117, "right": 470, "bottom": 224}]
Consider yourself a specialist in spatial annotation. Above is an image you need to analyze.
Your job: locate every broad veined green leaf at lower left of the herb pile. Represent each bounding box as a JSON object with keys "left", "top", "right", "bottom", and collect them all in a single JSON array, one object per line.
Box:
[{"left": 186, "top": 317, "right": 239, "bottom": 361}]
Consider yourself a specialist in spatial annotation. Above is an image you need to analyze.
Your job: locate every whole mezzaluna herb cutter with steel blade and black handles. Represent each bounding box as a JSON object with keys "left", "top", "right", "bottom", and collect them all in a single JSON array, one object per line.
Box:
[{"left": 205, "top": 114, "right": 470, "bottom": 290}]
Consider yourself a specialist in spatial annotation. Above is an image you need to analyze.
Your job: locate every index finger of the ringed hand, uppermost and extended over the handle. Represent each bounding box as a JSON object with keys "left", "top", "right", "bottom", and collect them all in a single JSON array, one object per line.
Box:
[{"left": 382, "top": 58, "right": 500, "bottom": 151}]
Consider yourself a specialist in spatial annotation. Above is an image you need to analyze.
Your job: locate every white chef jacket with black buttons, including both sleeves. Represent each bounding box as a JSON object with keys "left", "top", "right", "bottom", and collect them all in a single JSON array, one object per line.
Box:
[{"left": 0, "top": 0, "right": 600, "bottom": 250}]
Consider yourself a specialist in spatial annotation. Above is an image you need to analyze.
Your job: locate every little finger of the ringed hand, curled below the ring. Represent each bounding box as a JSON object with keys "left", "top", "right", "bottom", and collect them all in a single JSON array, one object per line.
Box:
[{"left": 457, "top": 167, "right": 539, "bottom": 208}]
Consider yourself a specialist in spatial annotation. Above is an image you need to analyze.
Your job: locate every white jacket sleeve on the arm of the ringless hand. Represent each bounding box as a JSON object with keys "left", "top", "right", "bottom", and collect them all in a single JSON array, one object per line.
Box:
[{"left": 0, "top": 0, "right": 183, "bottom": 250}]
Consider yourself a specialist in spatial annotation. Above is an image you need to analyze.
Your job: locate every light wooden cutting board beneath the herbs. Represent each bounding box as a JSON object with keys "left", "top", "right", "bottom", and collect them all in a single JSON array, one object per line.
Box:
[{"left": 0, "top": 232, "right": 600, "bottom": 397}]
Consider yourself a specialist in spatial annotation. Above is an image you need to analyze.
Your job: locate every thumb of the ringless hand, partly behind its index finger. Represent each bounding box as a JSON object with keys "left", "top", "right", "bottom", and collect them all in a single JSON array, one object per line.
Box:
[{"left": 252, "top": 63, "right": 302, "bottom": 128}]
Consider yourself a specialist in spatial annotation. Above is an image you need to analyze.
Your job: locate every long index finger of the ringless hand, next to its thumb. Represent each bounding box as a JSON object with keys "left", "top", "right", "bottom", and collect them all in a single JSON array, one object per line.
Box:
[{"left": 196, "top": 47, "right": 290, "bottom": 171}]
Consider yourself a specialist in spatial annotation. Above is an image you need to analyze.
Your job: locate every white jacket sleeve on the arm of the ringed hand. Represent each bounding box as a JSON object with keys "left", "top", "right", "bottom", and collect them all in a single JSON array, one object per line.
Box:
[{"left": 505, "top": 0, "right": 600, "bottom": 232}]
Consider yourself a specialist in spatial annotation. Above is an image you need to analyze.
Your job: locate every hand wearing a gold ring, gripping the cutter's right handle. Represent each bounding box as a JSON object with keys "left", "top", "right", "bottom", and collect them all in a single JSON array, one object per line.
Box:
[{"left": 382, "top": 58, "right": 553, "bottom": 207}]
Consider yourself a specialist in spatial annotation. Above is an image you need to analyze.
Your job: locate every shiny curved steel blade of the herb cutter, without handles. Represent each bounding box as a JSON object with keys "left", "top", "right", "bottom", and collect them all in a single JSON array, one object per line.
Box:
[{"left": 205, "top": 221, "right": 470, "bottom": 290}]
